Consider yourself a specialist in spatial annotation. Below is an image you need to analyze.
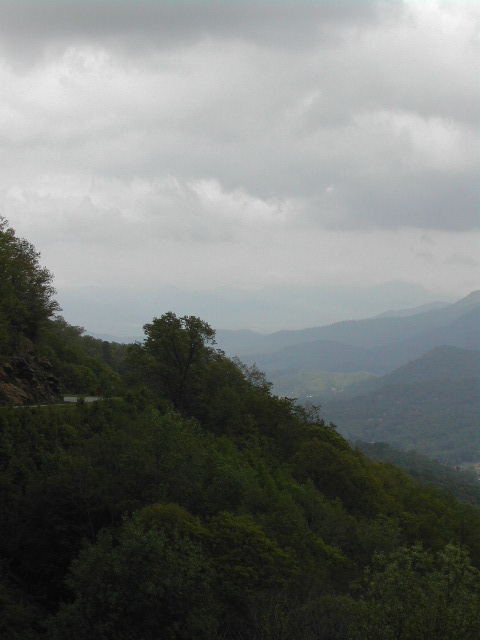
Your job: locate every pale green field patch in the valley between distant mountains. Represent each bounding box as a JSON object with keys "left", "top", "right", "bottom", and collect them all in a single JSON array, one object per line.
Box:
[{"left": 268, "top": 371, "right": 376, "bottom": 400}]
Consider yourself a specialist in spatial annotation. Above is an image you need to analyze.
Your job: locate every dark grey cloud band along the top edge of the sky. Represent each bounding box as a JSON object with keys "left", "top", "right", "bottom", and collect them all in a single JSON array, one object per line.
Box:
[{"left": 0, "top": 0, "right": 385, "bottom": 60}]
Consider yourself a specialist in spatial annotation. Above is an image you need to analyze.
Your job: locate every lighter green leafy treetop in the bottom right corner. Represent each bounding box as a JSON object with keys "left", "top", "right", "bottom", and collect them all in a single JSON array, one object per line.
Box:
[{"left": 352, "top": 544, "right": 480, "bottom": 640}]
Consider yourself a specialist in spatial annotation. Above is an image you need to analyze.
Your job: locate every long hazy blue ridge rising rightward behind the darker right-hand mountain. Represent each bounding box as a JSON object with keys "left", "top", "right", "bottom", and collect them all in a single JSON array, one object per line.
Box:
[{"left": 217, "top": 291, "right": 480, "bottom": 375}]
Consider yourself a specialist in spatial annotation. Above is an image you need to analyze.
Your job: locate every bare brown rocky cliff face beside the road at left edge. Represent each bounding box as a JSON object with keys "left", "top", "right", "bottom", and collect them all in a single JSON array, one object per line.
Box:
[{"left": 0, "top": 354, "right": 60, "bottom": 405}]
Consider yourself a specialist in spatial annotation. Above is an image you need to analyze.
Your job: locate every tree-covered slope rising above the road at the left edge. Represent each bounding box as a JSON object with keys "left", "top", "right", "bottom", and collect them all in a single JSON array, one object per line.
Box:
[{"left": 0, "top": 217, "right": 126, "bottom": 404}]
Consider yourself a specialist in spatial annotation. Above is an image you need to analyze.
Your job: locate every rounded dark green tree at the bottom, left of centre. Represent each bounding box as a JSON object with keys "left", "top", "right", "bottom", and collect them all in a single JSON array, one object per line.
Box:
[{"left": 52, "top": 513, "right": 216, "bottom": 640}]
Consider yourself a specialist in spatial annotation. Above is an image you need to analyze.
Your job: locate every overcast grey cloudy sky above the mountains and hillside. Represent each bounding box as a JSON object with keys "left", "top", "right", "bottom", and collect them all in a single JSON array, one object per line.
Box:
[{"left": 0, "top": 0, "right": 480, "bottom": 335}]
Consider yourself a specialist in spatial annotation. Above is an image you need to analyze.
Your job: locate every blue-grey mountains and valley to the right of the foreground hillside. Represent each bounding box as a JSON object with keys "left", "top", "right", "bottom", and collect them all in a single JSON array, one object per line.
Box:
[{"left": 217, "top": 291, "right": 480, "bottom": 465}]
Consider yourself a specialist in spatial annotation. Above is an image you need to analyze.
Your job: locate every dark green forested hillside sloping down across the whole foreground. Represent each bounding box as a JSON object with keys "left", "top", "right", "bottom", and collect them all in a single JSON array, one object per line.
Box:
[{"left": 0, "top": 218, "right": 480, "bottom": 640}]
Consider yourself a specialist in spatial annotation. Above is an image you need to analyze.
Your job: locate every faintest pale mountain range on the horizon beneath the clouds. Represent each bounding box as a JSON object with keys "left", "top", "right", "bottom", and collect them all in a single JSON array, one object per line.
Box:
[{"left": 60, "top": 282, "right": 446, "bottom": 340}]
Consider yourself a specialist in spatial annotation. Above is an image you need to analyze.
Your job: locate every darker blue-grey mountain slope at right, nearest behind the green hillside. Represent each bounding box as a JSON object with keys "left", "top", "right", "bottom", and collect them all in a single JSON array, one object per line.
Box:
[{"left": 314, "top": 347, "right": 480, "bottom": 464}]
